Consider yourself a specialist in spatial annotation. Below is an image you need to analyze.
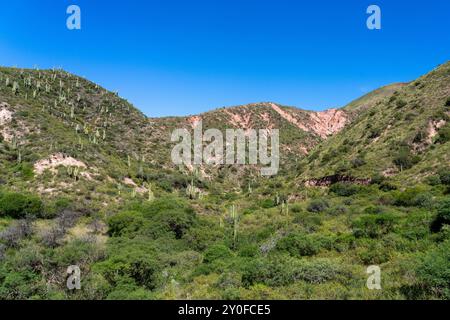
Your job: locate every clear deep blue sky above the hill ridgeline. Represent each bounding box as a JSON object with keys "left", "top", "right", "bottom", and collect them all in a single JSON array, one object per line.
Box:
[{"left": 0, "top": 0, "right": 450, "bottom": 116}]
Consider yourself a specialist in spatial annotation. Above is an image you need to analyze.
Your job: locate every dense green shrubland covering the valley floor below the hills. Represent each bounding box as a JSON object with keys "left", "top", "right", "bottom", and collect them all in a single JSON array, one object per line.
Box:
[{"left": 0, "top": 169, "right": 450, "bottom": 299}]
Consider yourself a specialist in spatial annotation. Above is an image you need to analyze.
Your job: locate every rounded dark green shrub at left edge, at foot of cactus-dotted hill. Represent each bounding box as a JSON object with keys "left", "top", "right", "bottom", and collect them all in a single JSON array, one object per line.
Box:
[{"left": 0, "top": 192, "right": 44, "bottom": 219}]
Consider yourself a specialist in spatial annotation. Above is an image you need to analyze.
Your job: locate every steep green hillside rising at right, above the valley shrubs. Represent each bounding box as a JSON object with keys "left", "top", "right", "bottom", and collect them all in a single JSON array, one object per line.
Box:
[{"left": 302, "top": 63, "right": 450, "bottom": 182}]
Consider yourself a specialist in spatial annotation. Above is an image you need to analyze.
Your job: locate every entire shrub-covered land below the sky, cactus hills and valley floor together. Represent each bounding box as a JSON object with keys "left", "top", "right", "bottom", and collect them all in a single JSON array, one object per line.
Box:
[{"left": 0, "top": 63, "right": 450, "bottom": 300}]
